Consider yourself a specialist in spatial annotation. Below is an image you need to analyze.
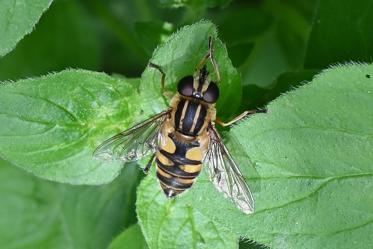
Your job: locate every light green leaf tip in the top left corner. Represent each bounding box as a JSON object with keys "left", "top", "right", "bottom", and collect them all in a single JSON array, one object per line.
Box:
[{"left": 0, "top": 0, "right": 52, "bottom": 57}]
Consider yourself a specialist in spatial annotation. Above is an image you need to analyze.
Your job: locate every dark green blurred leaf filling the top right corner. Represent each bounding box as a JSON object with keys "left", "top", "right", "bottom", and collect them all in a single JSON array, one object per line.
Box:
[{"left": 304, "top": 0, "right": 373, "bottom": 68}]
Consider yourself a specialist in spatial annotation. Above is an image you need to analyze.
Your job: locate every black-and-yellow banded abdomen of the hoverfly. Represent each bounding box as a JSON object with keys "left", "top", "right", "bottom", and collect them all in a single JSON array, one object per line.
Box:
[{"left": 156, "top": 133, "right": 202, "bottom": 197}]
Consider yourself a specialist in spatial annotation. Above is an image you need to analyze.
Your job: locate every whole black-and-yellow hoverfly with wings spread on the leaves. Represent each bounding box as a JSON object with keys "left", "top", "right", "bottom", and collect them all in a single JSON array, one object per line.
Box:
[{"left": 94, "top": 37, "right": 264, "bottom": 214}]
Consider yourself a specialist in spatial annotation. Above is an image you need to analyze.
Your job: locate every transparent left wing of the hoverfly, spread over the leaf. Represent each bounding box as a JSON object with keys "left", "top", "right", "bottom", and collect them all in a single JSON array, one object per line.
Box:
[{"left": 93, "top": 110, "right": 170, "bottom": 162}]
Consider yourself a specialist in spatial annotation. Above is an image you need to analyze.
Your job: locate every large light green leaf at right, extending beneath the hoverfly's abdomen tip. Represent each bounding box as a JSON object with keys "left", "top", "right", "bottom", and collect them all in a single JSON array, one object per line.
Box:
[{"left": 137, "top": 64, "right": 373, "bottom": 249}]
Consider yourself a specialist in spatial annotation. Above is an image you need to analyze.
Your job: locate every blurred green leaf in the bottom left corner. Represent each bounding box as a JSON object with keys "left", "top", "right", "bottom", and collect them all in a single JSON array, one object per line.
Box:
[{"left": 0, "top": 160, "right": 140, "bottom": 249}]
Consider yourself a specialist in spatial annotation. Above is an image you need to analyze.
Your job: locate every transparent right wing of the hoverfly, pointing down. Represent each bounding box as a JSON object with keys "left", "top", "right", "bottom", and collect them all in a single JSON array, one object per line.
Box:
[{"left": 204, "top": 124, "right": 254, "bottom": 214}]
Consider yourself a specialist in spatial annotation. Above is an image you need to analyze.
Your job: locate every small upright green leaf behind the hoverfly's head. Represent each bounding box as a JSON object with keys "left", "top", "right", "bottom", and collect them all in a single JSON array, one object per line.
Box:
[{"left": 140, "top": 21, "right": 241, "bottom": 117}]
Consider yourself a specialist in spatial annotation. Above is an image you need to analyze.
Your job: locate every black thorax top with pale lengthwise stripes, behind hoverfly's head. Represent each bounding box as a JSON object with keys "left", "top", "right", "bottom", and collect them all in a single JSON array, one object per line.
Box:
[{"left": 174, "top": 98, "right": 207, "bottom": 136}]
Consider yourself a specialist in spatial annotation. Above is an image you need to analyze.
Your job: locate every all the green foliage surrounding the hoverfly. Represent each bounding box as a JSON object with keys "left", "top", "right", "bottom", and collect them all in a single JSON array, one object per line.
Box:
[{"left": 0, "top": 0, "right": 373, "bottom": 249}]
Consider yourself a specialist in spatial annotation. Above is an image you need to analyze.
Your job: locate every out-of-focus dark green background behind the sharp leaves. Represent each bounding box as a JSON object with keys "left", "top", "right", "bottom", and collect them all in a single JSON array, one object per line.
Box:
[{"left": 0, "top": 0, "right": 373, "bottom": 248}]
